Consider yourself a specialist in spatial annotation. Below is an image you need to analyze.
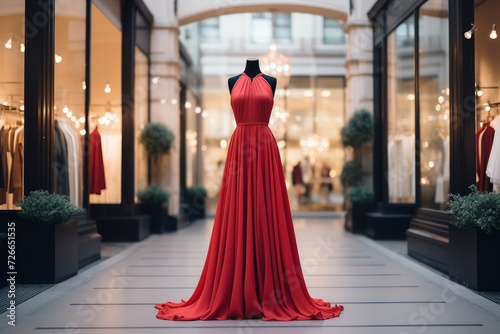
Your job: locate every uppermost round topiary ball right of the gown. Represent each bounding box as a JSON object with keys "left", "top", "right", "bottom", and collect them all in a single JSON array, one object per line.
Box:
[{"left": 340, "top": 109, "right": 374, "bottom": 147}]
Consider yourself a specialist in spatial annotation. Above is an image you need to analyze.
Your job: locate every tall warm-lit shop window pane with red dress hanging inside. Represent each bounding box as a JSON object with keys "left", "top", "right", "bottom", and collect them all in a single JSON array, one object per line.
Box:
[{"left": 89, "top": 4, "right": 122, "bottom": 204}]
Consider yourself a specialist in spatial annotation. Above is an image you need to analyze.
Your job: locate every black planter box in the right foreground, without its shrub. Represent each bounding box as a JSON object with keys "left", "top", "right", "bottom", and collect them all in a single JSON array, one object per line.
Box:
[{"left": 449, "top": 225, "right": 500, "bottom": 291}]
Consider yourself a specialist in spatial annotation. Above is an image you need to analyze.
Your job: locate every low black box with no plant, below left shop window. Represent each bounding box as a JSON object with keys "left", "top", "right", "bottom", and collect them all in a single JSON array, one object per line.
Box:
[{"left": 96, "top": 215, "right": 151, "bottom": 241}]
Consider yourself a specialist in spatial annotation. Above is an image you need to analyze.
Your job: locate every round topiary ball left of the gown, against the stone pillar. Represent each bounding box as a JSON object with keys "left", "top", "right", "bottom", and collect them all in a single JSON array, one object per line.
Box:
[{"left": 139, "top": 123, "right": 175, "bottom": 155}]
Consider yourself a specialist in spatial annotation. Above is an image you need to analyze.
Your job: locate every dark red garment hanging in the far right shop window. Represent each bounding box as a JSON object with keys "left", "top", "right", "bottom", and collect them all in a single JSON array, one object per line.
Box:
[{"left": 476, "top": 122, "right": 495, "bottom": 191}]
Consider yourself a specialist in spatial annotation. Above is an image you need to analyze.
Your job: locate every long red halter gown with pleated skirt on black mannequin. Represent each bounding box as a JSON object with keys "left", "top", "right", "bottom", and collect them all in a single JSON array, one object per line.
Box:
[{"left": 155, "top": 73, "right": 344, "bottom": 321}]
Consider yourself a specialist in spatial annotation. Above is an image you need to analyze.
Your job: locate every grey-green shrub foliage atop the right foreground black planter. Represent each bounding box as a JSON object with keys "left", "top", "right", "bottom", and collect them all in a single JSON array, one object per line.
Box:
[{"left": 448, "top": 185, "right": 500, "bottom": 233}]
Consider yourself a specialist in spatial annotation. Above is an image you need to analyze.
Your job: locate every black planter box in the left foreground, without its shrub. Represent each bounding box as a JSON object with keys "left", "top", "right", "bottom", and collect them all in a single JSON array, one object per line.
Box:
[{"left": 16, "top": 220, "right": 78, "bottom": 283}]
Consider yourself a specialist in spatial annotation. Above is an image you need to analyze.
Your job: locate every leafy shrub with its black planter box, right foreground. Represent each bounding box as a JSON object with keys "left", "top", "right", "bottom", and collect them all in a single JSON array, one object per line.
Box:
[{"left": 448, "top": 185, "right": 500, "bottom": 291}]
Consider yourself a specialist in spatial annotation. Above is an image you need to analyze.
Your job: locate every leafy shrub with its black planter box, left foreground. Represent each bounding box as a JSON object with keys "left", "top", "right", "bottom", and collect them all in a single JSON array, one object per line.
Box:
[{"left": 15, "top": 190, "right": 85, "bottom": 283}]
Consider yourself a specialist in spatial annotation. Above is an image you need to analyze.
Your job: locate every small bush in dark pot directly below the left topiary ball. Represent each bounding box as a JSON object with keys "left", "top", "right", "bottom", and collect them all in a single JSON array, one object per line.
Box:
[{"left": 137, "top": 185, "right": 175, "bottom": 234}]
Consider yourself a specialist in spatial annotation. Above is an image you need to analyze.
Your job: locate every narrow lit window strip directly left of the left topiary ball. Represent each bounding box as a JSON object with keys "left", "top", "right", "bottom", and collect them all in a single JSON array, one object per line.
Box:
[{"left": 134, "top": 46, "right": 149, "bottom": 202}]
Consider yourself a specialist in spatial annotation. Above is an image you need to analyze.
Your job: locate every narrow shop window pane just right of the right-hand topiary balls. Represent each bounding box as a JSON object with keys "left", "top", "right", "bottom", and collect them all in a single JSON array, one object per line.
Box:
[{"left": 387, "top": 16, "right": 416, "bottom": 203}]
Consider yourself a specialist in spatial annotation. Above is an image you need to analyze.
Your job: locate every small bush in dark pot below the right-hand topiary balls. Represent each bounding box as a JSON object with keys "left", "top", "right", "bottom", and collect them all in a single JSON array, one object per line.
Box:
[{"left": 346, "top": 186, "right": 373, "bottom": 233}]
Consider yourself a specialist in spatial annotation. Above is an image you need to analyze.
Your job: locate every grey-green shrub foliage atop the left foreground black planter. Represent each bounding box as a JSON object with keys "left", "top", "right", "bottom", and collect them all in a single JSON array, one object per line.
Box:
[{"left": 19, "top": 190, "right": 85, "bottom": 225}]
